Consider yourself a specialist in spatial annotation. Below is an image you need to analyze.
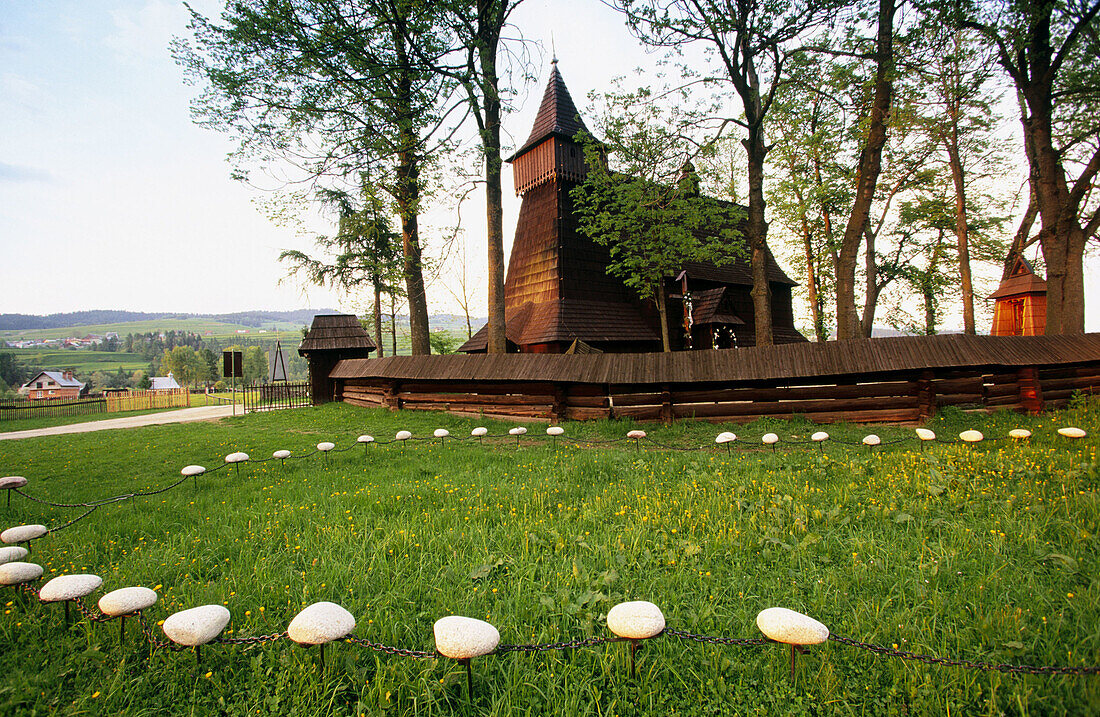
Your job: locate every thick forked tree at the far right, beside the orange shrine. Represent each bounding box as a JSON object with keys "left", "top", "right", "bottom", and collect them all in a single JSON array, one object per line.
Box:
[{"left": 960, "top": 0, "right": 1100, "bottom": 333}]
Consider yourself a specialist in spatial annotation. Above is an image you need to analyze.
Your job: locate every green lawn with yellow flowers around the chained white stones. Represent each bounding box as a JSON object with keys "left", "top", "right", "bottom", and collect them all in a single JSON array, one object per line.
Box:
[{"left": 0, "top": 404, "right": 1100, "bottom": 716}]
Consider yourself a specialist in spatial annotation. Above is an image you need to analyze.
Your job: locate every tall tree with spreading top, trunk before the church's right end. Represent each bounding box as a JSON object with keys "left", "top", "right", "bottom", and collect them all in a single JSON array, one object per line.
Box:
[{"left": 613, "top": 0, "right": 834, "bottom": 345}]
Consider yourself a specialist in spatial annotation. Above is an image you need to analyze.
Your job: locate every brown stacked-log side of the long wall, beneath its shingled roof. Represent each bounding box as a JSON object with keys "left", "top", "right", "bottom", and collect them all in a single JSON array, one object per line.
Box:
[{"left": 337, "top": 363, "right": 1100, "bottom": 423}]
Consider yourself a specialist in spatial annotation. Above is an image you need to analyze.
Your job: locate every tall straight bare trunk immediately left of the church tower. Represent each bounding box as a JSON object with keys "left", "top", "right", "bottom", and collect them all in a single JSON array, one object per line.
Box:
[{"left": 477, "top": 0, "right": 508, "bottom": 353}]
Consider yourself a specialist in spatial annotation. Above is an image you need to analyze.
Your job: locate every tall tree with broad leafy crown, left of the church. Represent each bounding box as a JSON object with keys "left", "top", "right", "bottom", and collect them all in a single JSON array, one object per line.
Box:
[{"left": 175, "top": 0, "right": 454, "bottom": 354}]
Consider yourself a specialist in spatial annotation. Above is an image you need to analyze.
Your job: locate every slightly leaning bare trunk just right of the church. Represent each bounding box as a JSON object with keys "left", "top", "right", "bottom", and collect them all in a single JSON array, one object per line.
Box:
[{"left": 836, "top": 0, "right": 897, "bottom": 341}]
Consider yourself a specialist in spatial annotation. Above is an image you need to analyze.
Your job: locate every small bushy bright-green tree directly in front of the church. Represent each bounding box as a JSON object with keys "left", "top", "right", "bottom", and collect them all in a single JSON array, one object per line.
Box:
[{"left": 571, "top": 94, "right": 744, "bottom": 351}]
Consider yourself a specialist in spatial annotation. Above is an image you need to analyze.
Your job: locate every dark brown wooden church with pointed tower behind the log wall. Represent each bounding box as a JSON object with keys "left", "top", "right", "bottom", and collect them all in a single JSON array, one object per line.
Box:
[{"left": 460, "top": 59, "right": 805, "bottom": 353}]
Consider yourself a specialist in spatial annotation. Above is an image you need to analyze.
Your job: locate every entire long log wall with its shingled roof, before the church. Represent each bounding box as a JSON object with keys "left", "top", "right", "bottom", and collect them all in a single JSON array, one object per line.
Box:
[{"left": 330, "top": 333, "right": 1100, "bottom": 423}]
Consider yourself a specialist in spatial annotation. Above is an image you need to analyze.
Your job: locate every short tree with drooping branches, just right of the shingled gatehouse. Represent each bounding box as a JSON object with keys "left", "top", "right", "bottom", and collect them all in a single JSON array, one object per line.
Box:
[{"left": 279, "top": 182, "right": 404, "bottom": 359}]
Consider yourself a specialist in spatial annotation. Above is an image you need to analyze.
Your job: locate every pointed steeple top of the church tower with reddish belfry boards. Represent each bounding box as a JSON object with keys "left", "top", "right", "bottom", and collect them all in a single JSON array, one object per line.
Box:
[{"left": 508, "top": 57, "right": 589, "bottom": 195}]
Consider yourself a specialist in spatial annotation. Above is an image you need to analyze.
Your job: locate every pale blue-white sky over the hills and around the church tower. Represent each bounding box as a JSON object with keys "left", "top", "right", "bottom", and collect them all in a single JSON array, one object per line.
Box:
[{"left": 0, "top": 0, "right": 1100, "bottom": 331}]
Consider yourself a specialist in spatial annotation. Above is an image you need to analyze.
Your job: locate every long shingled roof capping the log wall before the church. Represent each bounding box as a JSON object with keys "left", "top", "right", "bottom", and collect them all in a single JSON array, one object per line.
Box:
[{"left": 329, "top": 333, "right": 1100, "bottom": 385}]
